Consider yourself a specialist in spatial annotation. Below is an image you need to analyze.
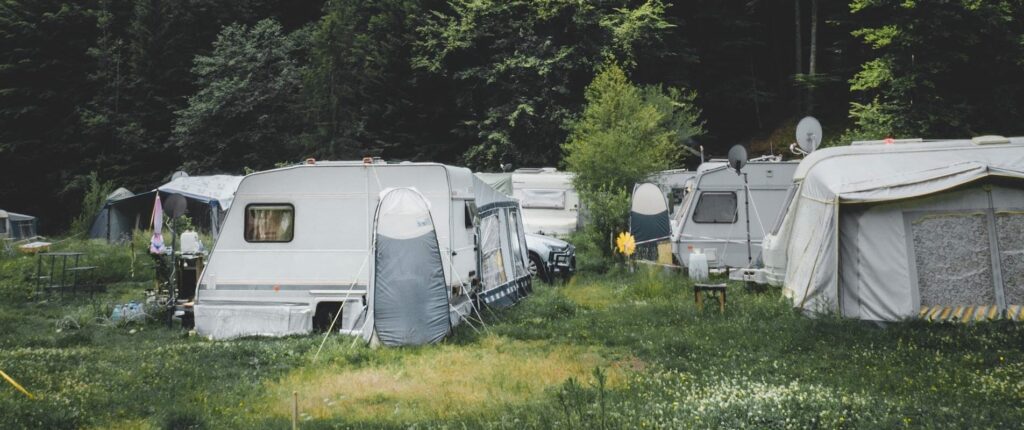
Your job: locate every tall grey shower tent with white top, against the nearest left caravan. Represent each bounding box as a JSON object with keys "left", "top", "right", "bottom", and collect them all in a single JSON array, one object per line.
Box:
[{"left": 364, "top": 188, "right": 452, "bottom": 346}]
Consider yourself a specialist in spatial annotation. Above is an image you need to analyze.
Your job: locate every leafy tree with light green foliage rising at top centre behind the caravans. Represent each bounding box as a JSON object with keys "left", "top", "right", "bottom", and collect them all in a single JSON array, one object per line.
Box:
[{"left": 416, "top": 0, "right": 670, "bottom": 170}]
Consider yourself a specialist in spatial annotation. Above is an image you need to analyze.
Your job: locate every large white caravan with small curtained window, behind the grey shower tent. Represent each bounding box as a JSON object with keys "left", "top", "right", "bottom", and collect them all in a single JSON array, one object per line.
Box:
[{"left": 194, "top": 160, "right": 529, "bottom": 339}]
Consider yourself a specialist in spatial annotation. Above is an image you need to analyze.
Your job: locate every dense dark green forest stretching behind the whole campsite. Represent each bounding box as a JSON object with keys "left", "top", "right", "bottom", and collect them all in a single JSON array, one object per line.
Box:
[{"left": 6, "top": 0, "right": 1024, "bottom": 233}]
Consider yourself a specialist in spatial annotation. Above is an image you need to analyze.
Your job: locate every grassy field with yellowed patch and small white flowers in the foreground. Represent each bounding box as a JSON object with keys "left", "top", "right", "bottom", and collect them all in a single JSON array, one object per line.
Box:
[{"left": 0, "top": 243, "right": 1024, "bottom": 429}]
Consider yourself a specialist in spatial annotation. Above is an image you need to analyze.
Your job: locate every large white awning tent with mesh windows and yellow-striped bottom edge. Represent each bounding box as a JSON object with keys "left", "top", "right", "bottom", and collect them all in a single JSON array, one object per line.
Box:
[{"left": 764, "top": 137, "right": 1024, "bottom": 320}]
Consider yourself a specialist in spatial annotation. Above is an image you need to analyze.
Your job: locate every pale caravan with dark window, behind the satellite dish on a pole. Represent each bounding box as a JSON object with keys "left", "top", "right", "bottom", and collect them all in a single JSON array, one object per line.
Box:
[{"left": 672, "top": 157, "right": 799, "bottom": 268}]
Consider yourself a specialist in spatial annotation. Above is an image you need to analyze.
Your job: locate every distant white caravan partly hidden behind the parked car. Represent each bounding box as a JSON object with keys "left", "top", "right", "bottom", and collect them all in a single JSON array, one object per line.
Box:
[{"left": 512, "top": 167, "right": 580, "bottom": 237}]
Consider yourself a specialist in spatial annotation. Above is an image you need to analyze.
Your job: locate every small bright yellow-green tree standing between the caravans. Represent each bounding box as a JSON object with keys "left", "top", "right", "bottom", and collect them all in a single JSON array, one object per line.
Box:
[{"left": 562, "top": 66, "right": 703, "bottom": 253}]
